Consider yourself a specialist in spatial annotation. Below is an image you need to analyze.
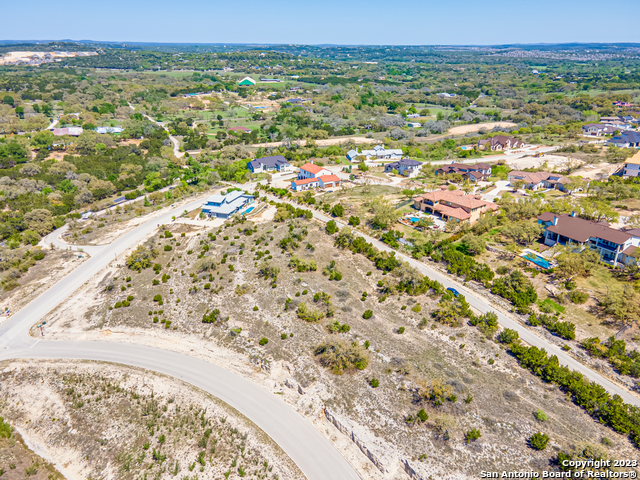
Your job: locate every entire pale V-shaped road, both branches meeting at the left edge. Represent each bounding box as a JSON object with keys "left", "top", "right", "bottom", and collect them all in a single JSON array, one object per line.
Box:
[{"left": 0, "top": 199, "right": 360, "bottom": 480}]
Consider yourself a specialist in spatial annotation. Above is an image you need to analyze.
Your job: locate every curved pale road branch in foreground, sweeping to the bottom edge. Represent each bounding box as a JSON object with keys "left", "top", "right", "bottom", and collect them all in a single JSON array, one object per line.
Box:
[{"left": 0, "top": 339, "right": 360, "bottom": 480}]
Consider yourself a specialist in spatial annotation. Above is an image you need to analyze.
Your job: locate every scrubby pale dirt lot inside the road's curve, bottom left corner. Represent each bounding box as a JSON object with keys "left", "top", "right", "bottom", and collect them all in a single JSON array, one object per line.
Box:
[{"left": 0, "top": 361, "right": 304, "bottom": 480}]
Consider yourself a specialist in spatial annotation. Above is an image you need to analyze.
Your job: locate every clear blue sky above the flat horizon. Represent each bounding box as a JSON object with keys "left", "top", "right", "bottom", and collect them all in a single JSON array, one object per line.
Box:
[{"left": 5, "top": 0, "right": 640, "bottom": 45}]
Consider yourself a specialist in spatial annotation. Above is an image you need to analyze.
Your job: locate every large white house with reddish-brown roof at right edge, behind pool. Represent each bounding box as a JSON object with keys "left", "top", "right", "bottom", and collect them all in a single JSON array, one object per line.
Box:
[{"left": 538, "top": 212, "right": 640, "bottom": 267}]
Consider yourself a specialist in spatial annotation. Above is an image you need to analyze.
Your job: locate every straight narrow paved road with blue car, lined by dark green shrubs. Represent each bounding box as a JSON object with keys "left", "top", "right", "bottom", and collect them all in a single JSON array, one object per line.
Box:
[{"left": 264, "top": 193, "right": 640, "bottom": 406}]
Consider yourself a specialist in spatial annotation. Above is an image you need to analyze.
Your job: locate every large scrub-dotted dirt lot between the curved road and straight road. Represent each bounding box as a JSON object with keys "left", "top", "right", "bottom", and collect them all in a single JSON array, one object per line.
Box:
[{"left": 41, "top": 216, "right": 637, "bottom": 479}]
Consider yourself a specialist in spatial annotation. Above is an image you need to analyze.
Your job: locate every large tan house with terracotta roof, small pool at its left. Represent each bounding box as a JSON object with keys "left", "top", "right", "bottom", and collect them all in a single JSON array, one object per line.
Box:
[{"left": 413, "top": 187, "right": 498, "bottom": 224}]
